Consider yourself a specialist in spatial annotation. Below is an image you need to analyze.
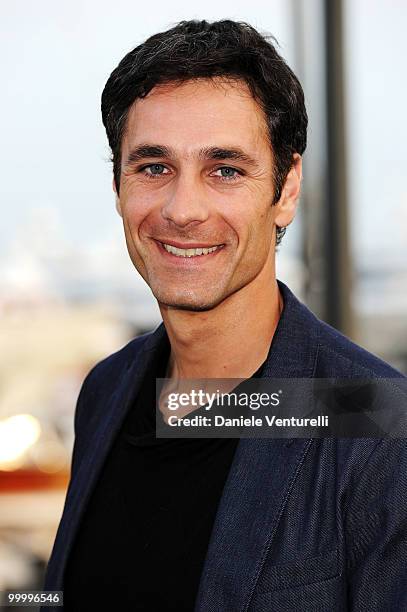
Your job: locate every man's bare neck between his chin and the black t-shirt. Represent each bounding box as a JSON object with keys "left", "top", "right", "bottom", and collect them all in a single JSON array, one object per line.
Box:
[{"left": 160, "top": 271, "right": 283, "bottom": 379}]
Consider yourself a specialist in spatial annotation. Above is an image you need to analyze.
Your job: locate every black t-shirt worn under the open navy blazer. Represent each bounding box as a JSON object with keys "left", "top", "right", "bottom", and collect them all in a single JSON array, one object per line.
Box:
[{"left": 64, "top": 345, "right": 268, "bottom": 612}]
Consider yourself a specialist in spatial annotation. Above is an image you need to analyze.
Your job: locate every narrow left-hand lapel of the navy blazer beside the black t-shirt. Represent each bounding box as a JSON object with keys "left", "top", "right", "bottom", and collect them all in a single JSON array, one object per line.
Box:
[{"left": 47, "top": 324, "right": 169, "bottom": 590}]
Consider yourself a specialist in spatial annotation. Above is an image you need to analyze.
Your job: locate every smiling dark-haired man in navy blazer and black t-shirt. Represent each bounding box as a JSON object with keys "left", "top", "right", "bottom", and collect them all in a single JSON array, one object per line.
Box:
[{"left": 45, "top": 20, "right": 407, "bottom": 612}]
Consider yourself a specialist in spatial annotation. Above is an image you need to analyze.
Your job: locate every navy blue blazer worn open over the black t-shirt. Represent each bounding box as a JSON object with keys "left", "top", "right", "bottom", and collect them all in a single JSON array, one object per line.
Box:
[{"left": 42, "top": 282, "right": 407, "bottom": 612}]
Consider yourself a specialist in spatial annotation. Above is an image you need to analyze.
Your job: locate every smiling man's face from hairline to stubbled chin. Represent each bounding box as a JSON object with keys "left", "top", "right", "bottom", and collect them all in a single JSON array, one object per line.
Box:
[{"left": 118, "top": 79, "right": 296, "bottom": 310}]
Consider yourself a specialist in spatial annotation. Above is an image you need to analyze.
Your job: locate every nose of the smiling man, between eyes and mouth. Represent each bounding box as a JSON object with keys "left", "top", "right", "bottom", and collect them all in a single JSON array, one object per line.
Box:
[{"left": 161, "top": 172, "right": 209, "bottom": 227}]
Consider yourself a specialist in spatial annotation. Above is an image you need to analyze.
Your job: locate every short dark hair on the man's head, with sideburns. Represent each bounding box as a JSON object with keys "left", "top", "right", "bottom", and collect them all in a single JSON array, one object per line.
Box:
[{"left": 102, "top": 19, "right": 308, "bottom": 244}]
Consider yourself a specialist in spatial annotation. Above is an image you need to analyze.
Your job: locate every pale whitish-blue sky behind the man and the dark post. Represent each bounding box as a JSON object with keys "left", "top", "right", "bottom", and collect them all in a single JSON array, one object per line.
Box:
[{"left": 0, "top": 0, "right": 407, "bottom": 266}]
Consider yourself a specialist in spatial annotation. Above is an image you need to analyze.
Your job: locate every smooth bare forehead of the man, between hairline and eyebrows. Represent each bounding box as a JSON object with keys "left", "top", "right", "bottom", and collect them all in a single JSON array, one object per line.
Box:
[{"left": 122, "top": 79, "right": 269, "bottom": 155}]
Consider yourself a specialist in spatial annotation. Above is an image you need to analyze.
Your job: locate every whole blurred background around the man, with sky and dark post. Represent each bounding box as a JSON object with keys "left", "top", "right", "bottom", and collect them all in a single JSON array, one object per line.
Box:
[{"left": 0, "top": 0, "right": 407, "bottom": 609}]
